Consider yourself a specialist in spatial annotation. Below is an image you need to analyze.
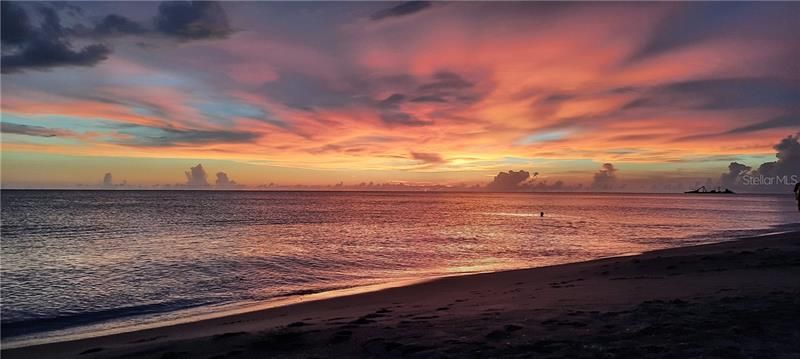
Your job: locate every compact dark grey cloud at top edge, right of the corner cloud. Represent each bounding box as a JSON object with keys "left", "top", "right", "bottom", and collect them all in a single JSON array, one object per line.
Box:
[{"left": 154, "top": 1, "right": 233, "bottom": 40}]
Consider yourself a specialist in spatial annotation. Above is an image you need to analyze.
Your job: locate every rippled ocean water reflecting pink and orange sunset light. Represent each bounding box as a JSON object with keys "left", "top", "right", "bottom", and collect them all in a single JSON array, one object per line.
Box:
[{"left": 0, "top": 190, "right": 800, "bottom": 346}]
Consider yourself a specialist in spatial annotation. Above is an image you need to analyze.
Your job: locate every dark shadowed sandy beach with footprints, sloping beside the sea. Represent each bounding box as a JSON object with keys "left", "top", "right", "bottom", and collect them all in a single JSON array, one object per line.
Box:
[{"left": 2, "top": 233, "right": 800, "bottom": 359}]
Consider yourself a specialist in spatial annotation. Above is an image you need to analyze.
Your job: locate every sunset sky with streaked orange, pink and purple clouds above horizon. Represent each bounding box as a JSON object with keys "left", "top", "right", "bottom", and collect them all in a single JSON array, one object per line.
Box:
[{"left": 2, "top": 1, "right": 800, "bottom": 191}]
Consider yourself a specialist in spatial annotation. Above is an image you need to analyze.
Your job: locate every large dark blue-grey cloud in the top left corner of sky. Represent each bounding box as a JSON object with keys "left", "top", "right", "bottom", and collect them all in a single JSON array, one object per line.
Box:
[{"left": 1, "top": 1, "right": 111, "bottom": 74}]
